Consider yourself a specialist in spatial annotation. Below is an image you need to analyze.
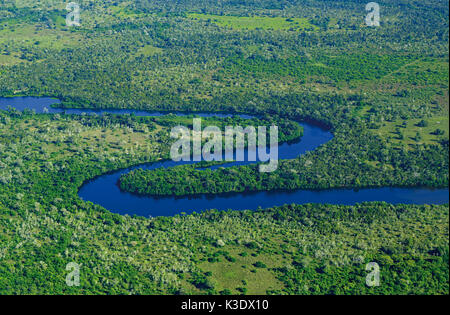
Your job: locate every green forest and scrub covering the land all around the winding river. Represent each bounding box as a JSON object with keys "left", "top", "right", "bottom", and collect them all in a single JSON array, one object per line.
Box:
[{"left": 0, "top": 0, "right": 449, "bottom": 294}]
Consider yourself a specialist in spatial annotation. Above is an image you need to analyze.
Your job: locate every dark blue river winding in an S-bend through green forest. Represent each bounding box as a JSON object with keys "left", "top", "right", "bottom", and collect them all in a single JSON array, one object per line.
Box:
[{"left": 0, "top": 97, "right": 449, "bottom": 217}]
